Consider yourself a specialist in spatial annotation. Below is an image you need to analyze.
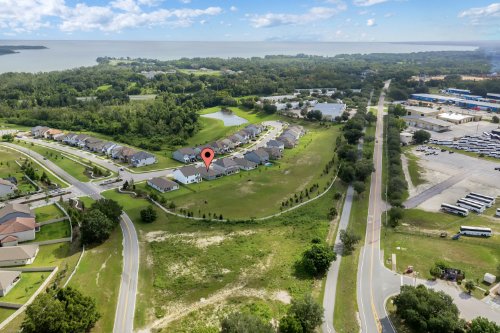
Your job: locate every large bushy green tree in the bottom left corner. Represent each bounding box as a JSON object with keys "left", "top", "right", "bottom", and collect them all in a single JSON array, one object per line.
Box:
[{"left": 21, "top": 287, "right": 100, "bottom": 333}]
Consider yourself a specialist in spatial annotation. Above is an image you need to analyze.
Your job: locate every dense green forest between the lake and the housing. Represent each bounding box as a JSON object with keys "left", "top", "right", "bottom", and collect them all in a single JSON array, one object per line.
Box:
[{"left": 0, "top": 52, "right": 490, "bottom": 149}]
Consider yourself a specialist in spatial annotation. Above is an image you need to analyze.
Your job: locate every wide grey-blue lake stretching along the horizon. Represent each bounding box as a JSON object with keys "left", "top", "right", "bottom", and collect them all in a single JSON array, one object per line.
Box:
[{"left": 0, "top": 40, "right": 476, "bottom": 73}]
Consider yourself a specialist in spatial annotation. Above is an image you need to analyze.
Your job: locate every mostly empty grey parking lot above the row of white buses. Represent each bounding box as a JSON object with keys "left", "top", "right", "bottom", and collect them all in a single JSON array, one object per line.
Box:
[{"left": 406, "top": 147, "right": 500, "bottom": 211}]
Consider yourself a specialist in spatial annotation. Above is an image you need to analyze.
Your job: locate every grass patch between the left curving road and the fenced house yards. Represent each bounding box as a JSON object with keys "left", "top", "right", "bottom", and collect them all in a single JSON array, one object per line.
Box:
[{"left": 69, "top": 224, "right": 122, "bottom": 333}]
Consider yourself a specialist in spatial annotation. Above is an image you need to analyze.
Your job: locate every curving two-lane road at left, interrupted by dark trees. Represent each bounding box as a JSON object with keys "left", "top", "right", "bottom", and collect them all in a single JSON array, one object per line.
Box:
[{"left": 4, "top": 143, "right": 139, "bottom": 333}]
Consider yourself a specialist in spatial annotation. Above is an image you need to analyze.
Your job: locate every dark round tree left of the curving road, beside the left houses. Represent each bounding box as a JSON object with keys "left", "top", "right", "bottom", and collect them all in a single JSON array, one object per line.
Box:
[{"left": 80, "top": 209, "right": 115, "bottom": 244}]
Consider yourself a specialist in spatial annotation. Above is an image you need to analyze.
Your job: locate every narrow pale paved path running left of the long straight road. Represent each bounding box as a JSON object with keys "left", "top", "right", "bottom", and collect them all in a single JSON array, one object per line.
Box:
[{"left": 321, "top": 185, "right": 354, "bottom": 333}]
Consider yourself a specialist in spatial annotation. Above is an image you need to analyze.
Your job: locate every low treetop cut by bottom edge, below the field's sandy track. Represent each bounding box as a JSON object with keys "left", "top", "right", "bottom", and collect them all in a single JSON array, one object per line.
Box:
[{"left": 220, "top": 312, "right": 274, "bottom": 333}]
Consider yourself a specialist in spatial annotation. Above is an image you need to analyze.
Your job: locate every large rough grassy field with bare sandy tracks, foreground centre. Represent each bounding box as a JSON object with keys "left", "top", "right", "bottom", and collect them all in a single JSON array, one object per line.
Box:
[{"left": 104, "top": 179, "right": 344, "bottom": 332}]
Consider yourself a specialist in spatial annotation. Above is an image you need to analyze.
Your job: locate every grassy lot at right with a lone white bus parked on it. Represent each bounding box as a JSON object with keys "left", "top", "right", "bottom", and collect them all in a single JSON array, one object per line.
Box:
[{"left": 382, "top": 209, "right": 500, "bottom": 296}]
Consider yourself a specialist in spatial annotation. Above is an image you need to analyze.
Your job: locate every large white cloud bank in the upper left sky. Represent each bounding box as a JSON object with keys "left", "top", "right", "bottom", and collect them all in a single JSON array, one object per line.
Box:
[{"left": 0, "top": 0, "right": 222, "bottom": 33}]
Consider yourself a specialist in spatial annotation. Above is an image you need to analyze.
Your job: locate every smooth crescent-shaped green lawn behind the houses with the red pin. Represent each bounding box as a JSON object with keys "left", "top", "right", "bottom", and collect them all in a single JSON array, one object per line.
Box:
[{"left": 145, "top": 125, "right": 339, "bottom": 219}]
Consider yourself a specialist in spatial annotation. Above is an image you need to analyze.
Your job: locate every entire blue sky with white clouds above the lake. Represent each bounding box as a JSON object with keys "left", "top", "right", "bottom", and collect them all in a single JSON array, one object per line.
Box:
[{"left": 0, "top": 0, "right": 500, "bottom": 42}]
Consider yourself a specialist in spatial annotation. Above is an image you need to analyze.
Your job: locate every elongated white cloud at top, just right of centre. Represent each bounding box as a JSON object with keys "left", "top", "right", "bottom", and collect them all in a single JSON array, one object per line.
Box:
[{"left": 250, "top": 2, "right": 347, "bottom": 28}]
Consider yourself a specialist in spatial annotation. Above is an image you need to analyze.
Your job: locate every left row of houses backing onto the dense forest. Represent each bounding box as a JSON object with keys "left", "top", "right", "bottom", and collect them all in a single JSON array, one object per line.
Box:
[{"left": 31, "top": 126, "right": 156, "bottom": 167}]
